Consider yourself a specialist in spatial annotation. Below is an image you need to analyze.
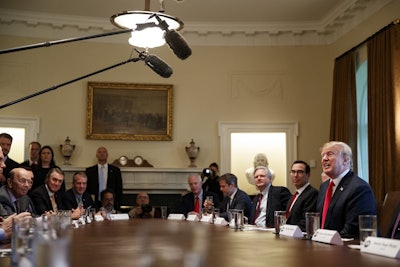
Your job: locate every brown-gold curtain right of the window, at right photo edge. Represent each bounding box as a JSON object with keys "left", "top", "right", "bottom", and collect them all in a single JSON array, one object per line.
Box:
[{"left": 367, "top": 22, "right": 400, "bottom": 202}]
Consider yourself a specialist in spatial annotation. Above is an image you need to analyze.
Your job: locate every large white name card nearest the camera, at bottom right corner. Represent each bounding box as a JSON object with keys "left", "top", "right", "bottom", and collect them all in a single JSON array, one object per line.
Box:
[{"left": 361, "top": 236, "right": 400, "bottom": 259}]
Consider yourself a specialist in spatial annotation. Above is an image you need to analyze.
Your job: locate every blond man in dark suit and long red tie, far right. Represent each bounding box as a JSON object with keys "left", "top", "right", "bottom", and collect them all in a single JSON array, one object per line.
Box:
[{"left": 317, "top": 141, "right": 376, "bottom": 238}]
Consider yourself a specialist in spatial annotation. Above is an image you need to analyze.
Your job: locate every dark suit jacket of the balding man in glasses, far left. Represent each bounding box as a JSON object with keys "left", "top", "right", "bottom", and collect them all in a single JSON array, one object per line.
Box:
[{"left": 0, "top": 185, "right": 36, "bottom": 217}]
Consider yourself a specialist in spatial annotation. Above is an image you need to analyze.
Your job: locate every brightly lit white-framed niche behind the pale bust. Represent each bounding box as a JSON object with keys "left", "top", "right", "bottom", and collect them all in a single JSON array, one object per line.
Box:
[{"left": 219, "top": 122, "right": 298, "bottom": 195}]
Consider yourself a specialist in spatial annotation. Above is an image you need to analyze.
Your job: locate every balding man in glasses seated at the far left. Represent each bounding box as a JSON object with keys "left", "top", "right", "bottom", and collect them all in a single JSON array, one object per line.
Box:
[{"left": 0, "top": 166, "right": 36, "bottom": 217}]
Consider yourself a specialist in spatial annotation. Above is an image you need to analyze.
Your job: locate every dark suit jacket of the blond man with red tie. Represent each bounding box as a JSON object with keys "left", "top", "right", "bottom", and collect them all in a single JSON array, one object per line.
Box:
[{"left": 317, "top": 173, "right": 376, "bottom": 238}]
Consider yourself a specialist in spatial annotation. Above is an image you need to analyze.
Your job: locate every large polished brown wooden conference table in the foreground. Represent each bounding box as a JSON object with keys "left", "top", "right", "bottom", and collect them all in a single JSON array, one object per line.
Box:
[{"left": 0, "top": 219, "right": 400, "bottom": 267}]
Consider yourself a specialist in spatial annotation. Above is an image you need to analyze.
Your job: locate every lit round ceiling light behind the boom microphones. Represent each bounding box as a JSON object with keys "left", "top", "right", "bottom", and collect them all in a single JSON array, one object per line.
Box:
[{"left": 111, "top": 11, "right": 183, "bottom": 49}]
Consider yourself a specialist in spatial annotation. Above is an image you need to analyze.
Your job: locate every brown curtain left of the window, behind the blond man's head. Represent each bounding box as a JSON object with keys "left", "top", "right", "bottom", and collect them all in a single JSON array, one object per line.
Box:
[{"left": 330, "top": 51, "right": 357, "bottom": 172}]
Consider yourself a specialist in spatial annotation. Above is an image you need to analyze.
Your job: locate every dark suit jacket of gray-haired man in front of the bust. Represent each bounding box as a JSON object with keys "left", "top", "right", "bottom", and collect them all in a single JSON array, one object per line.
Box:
[{"left": 251, "top": 185, "right": 292, "bottom": 228}]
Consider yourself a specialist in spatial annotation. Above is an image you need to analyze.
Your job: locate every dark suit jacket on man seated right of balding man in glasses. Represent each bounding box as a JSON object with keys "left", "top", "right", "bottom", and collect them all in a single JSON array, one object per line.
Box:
[{"left": 29, "top": 184, "right": 64, "bottom": 215}]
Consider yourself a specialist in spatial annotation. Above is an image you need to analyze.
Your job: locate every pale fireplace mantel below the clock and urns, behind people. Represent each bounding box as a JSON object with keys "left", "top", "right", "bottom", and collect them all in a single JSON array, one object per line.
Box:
[{"left": 61, "top": 166, "right": 202, "bottom": 194}]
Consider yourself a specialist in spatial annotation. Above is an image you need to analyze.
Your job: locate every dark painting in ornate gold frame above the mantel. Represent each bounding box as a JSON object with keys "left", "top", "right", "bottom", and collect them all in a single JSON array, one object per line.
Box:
[{"left": 87, "top": 82, "right": 173, "bottom": 141}]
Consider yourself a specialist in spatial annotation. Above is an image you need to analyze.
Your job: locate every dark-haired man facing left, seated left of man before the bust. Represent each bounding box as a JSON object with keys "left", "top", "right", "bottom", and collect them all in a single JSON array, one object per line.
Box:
[{"left": 218, "top": 173, "right": 253, "bottom": 221}]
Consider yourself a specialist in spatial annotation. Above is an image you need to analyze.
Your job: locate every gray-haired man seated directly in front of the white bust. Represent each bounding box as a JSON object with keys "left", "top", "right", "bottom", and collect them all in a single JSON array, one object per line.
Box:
[{"left": 252, "top": 166, "right": 292, "bottom": 228}]
